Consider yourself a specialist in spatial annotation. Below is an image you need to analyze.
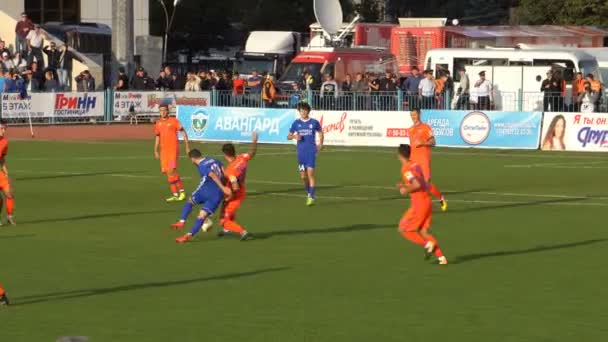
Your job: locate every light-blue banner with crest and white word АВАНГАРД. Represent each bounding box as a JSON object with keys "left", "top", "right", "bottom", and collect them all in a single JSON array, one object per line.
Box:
[{"left": 177, "top": 106, "right": 296, "bottom": 144}]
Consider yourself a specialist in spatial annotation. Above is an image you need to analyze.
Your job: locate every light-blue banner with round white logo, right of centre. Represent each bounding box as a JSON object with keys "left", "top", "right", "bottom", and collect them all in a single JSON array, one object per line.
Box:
[{"left": 422, "top": 110, "right": 542, "bottom": 149}]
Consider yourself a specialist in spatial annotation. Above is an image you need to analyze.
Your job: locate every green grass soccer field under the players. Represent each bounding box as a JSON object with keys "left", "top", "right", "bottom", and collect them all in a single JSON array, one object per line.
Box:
[{"left": 0, "top": 141, "right": 608, "bottom": 342}]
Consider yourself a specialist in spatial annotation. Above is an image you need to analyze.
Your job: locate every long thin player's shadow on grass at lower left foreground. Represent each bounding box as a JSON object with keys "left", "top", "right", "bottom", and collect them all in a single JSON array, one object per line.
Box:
[{"left": 13, "top": 267, "right": 291, "bottom": 306}]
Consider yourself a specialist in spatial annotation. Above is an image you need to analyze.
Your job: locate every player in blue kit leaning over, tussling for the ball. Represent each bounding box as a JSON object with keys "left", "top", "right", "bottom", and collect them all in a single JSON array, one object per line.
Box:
[{"left": 171, "top": 149, "right": 232, "bottom": 243}]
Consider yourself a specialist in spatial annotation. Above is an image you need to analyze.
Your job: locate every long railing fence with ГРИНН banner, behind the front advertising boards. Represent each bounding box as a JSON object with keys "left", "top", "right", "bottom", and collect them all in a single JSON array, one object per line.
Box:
[{"left": 0, "top": 89, "right": 608, "bottom": 124}]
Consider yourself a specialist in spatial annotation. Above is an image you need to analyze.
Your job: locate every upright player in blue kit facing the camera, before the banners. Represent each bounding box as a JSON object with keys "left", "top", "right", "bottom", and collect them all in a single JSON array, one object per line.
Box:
[{"left": 287, "top": 102, "right": 323, "bottom": 206}]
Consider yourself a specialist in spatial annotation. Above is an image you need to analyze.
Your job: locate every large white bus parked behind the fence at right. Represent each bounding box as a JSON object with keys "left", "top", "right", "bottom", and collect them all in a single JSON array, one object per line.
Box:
[{"left": 425, "top": 48, "right": 603, "bottom": 111}]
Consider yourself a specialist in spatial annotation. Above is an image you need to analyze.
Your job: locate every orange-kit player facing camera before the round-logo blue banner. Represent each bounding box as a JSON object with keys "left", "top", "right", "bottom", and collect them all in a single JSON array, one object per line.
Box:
[{"left": 409, "top": 109, "right": 448, "bottom": 211}]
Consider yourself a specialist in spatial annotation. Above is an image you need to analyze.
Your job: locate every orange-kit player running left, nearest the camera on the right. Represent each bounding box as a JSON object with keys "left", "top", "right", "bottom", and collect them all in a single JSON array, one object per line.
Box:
[{"left": 397, "top": 144, "right": 448, "bottom": 265}]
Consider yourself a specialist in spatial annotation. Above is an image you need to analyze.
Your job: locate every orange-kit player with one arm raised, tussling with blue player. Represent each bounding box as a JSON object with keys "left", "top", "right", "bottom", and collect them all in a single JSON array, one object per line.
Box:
[{"left": 219, "top": 132, "right": 258, "bottom": 241}]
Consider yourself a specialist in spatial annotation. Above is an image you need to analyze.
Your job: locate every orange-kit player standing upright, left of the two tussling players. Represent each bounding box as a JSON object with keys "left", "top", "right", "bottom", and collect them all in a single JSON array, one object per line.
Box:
[{"left": 154, "top": 104, "right": 190, "bottom": 202}]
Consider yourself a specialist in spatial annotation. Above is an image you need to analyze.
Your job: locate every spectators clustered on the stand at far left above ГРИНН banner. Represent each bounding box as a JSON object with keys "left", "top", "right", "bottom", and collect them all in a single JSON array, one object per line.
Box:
[{"left": 0, "top": 13, "right": 86, "bottom": 95}]
